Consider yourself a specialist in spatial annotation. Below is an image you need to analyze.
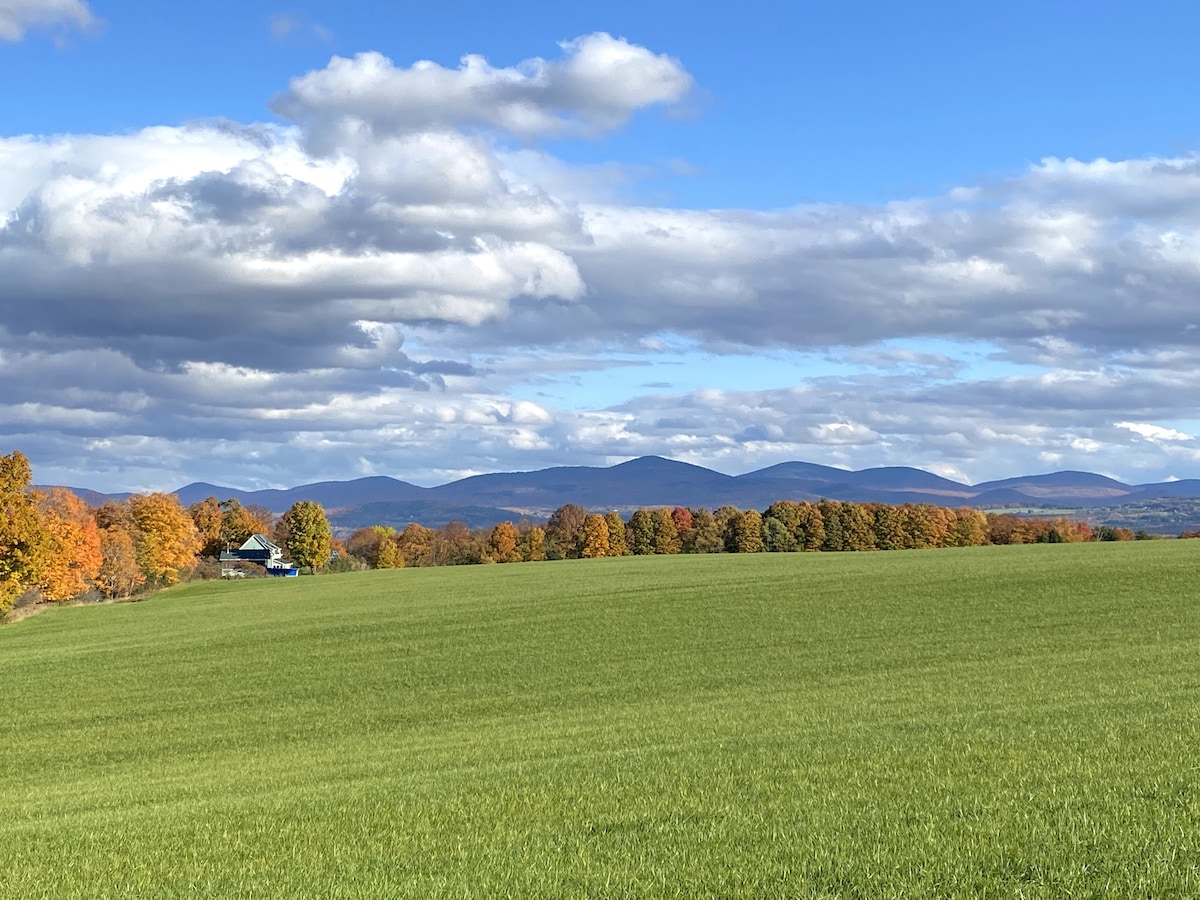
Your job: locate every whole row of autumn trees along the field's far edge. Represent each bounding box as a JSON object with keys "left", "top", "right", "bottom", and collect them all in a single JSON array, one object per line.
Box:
[{"left": 0, "top": 451, "right": 1142, "bottom": 616}]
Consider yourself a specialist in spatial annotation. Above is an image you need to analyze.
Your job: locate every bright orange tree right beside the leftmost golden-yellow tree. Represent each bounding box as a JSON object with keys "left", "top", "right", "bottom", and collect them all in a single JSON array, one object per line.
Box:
[{"left": 37, "top": 487, "right": 103, "bottom": 600}]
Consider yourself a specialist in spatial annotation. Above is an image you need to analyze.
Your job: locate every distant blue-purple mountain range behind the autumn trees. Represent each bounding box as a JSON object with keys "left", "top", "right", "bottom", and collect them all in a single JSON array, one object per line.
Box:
[{"left": 35, "top": 456, "right": 1200, "bottom": 530}]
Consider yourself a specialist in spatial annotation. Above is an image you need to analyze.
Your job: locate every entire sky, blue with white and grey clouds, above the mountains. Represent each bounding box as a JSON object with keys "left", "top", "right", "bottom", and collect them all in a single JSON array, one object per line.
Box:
[{"left": 0, "top": 0, "right": 1200, "bottom": 490}]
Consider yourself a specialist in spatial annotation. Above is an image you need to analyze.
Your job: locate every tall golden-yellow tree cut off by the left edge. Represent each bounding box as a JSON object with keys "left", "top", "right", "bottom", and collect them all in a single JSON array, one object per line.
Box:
[{"left": 0, "top": 450, "right": 47, "bottom": 614}]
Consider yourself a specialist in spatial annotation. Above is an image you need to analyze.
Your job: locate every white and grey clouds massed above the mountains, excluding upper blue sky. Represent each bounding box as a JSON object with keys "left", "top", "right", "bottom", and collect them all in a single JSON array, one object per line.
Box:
[{"left": 0, "top": 17, "right": 1200, "bottom": 490}]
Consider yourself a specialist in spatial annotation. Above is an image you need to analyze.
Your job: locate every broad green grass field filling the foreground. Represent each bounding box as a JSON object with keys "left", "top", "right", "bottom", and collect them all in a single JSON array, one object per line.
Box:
[{"left": 0, "top": 541, "right": 1200, "bottom": 898}]
